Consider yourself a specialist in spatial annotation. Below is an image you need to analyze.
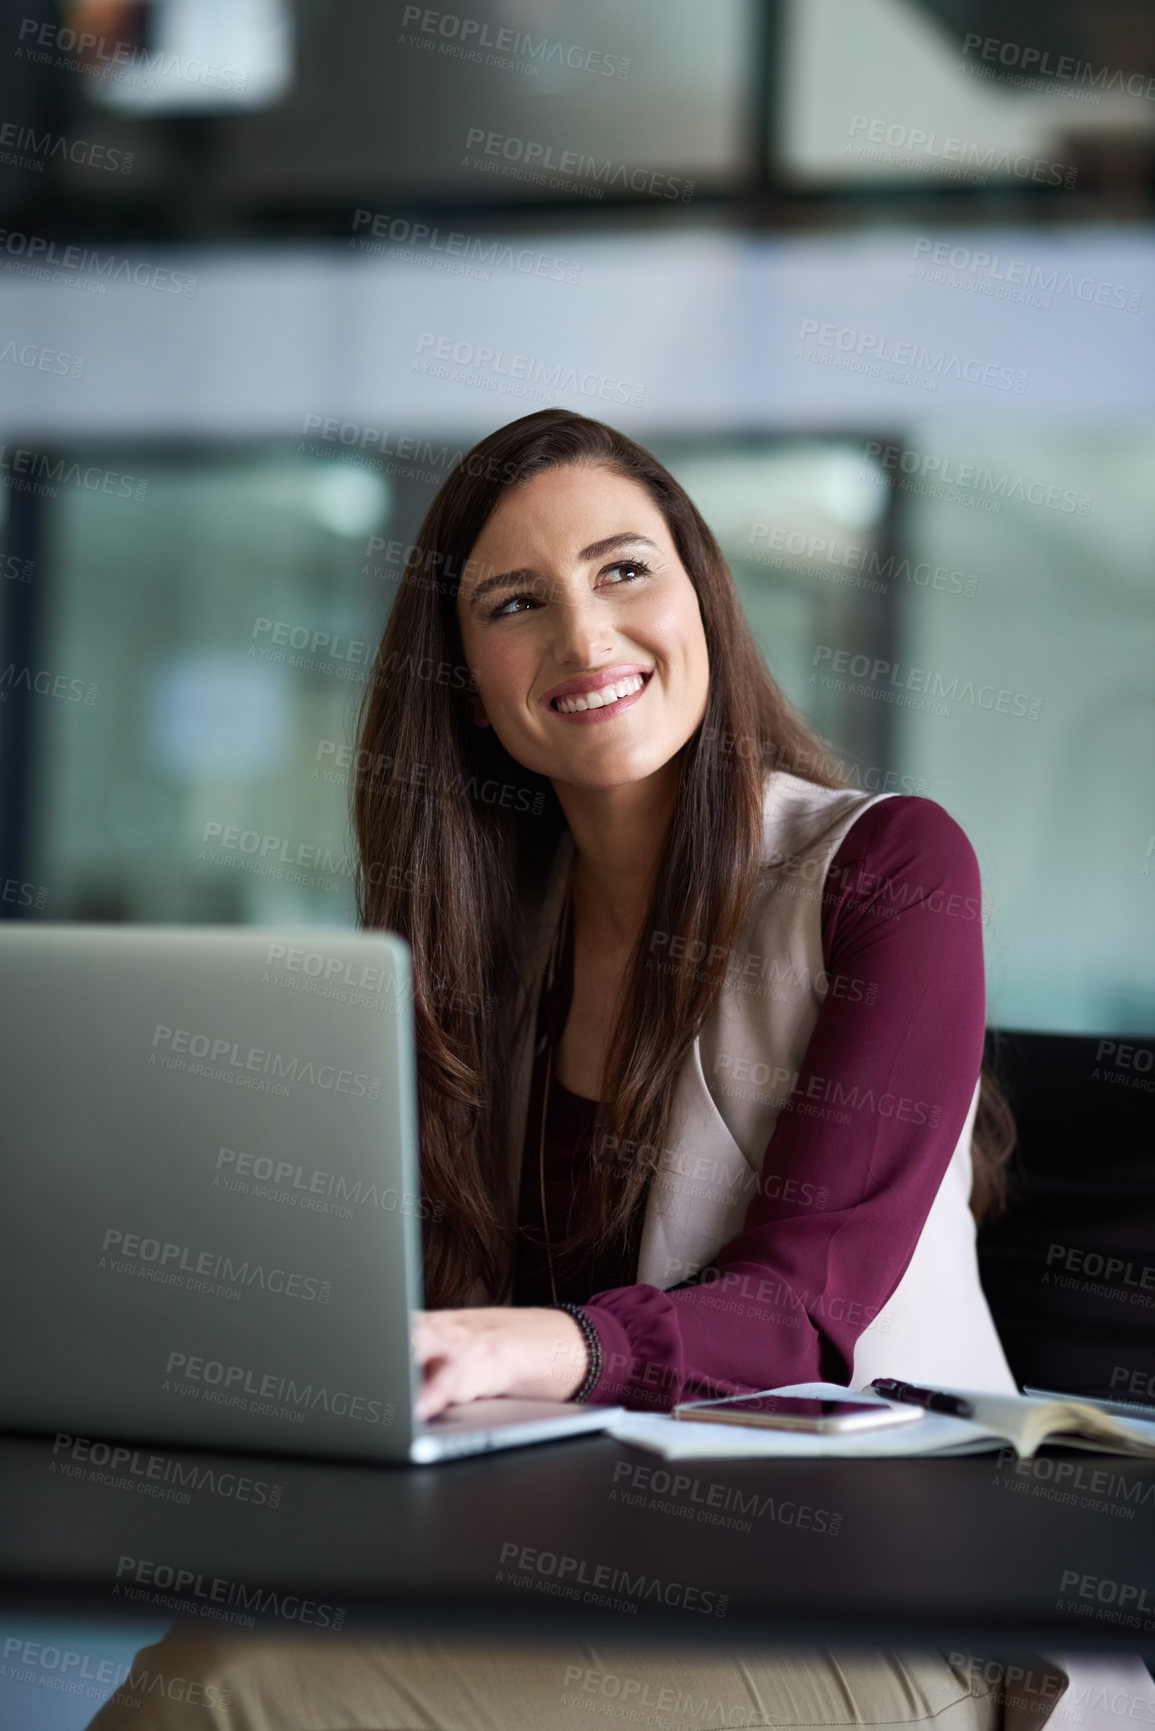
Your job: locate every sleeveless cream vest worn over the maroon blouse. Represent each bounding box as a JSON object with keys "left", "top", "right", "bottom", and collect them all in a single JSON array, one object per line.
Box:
[{"left": 513, "top": 772, "right": 1016, "bottom": 1393}]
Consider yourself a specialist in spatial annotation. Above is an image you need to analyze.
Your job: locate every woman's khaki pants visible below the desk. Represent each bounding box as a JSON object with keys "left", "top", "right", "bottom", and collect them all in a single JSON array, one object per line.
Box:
[{"left": 90, "top": 1624, "right": 1055, "bottom": 1731}]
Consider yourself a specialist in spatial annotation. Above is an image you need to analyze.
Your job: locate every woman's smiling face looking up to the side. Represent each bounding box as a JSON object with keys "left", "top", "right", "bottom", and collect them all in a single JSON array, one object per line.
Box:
[{"left": 457, "top": 464, "right": 710, "bottom": 788}]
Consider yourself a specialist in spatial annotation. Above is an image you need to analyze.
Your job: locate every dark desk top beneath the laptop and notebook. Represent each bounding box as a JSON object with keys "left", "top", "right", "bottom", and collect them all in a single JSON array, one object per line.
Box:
[{"left": 0, "top": 1437, "right": 1155, "bottom": 1657}]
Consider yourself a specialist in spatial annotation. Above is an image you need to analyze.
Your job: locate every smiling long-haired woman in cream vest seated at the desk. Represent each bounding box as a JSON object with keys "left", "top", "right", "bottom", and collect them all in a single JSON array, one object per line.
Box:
[{"left": 94, "top": 410, "right": 1056, "bottom": 1731}]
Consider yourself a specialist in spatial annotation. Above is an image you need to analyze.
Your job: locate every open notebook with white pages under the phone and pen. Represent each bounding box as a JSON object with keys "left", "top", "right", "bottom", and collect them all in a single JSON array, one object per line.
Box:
[{"left": 606, "top": 1383, "right": 1155, "bottom": 1461}]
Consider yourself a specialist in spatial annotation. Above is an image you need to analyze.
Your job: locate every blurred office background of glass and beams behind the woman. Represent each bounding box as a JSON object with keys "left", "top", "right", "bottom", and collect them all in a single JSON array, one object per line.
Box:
[{"left": 0, "top": 0, "right": 1155, "bottom": 1033}]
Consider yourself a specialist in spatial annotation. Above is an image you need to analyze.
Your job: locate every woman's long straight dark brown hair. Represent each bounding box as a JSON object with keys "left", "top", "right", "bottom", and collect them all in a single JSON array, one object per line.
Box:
[{"left": 353, "top": 409, "right": 1013, "bottom": 1309}]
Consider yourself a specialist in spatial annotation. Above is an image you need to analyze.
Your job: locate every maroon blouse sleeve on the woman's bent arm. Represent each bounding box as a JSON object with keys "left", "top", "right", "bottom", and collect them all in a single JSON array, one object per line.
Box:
[{"left": 582, "top": 795, "right": 985, "bottom": 1411}]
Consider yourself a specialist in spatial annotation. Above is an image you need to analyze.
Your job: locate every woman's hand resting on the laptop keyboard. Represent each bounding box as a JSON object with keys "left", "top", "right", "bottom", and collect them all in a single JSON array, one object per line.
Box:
[{"left": 410, "top": 1305, "right": 589, "bottom": 1419}]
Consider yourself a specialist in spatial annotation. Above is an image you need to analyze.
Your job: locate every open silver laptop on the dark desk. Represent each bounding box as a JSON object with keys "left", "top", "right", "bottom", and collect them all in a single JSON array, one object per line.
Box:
[{"left": 0, "top": 923, "right": 622, "bottom": 1463}]
